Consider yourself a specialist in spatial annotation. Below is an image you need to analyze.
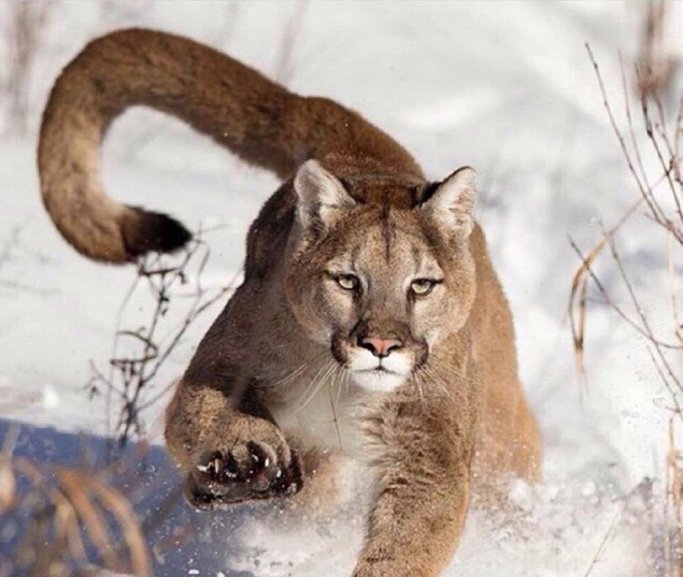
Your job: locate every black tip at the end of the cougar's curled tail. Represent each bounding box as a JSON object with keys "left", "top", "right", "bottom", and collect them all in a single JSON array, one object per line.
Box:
[{"left": 121, "top": 207, "right": 192, "bottom": 258}]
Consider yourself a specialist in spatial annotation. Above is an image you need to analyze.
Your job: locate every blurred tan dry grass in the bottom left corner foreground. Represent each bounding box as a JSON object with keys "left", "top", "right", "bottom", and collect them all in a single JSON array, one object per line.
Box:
[{"left": 0, "top": 432, "right": 152, "bottom": 577}]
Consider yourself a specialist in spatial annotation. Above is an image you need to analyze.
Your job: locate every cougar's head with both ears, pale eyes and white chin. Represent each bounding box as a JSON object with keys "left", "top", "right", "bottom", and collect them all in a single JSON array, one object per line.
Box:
[{"left": 285, "top": 160, "right": 475, "bottom": 391}]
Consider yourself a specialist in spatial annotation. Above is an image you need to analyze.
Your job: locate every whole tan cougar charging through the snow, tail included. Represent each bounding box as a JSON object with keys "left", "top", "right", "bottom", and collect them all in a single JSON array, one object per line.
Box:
[{"left": 39, "top": 30, "right": 540, "bottom": 577}]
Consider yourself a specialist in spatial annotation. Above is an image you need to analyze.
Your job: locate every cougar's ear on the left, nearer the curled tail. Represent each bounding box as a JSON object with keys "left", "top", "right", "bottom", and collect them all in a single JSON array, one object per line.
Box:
[{"left": 294, "top": 160, "right": 356, "bottom": 230}]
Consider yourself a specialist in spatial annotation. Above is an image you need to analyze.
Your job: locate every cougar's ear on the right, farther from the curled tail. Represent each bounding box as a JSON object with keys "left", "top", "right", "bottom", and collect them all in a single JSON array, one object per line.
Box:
[{"left": 422, "top": 166, "right": 477, "bottom": 239}]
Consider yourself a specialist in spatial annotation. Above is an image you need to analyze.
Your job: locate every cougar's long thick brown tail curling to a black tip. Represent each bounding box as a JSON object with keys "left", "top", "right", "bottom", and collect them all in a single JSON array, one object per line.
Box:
[{"left": 38, "top": 30, "right": 419, "bottom": 262}]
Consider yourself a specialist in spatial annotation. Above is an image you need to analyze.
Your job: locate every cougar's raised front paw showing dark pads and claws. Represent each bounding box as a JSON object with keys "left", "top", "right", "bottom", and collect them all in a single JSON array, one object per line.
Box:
[{"left": 186, "top": 426, "right": 302, "bottom": 510}]
